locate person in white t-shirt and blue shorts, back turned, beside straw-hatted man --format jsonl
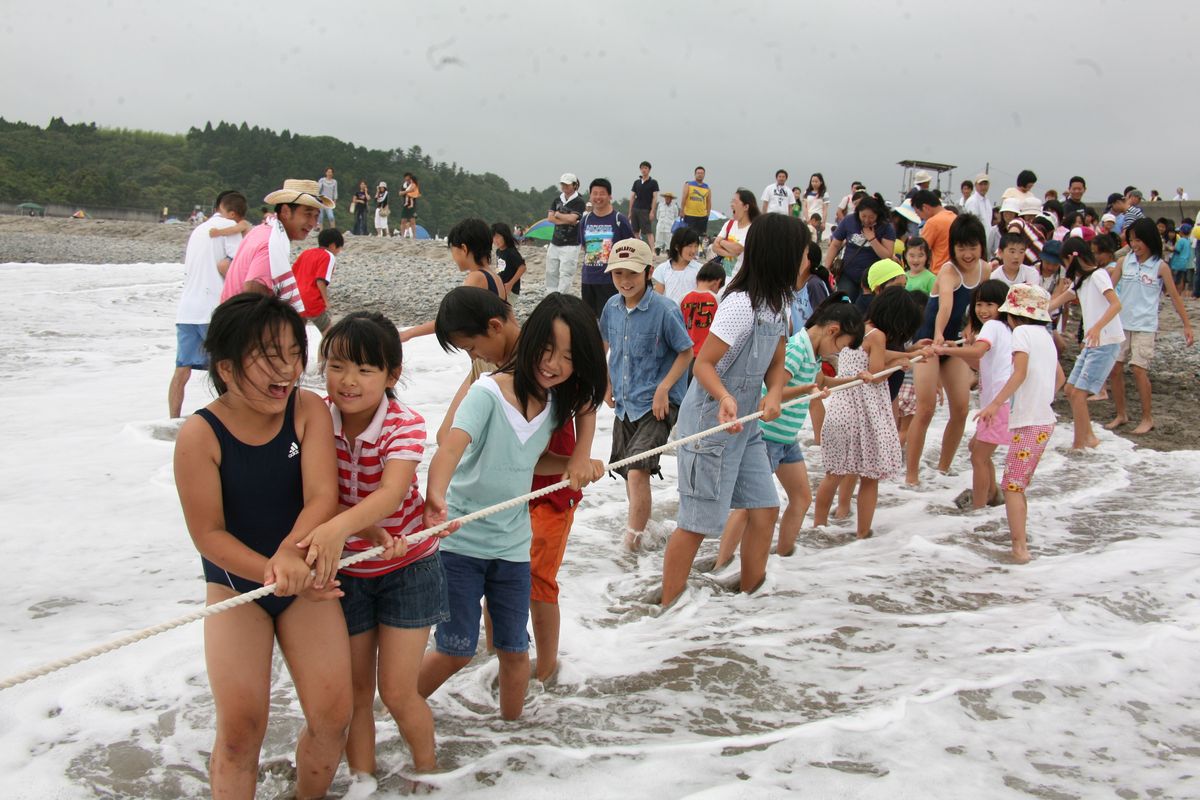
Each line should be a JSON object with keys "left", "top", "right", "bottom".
{"left": 167, "top": 192, "right": 246, "bottom": 419}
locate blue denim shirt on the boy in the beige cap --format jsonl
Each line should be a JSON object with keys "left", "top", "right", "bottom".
{"left": 600, "top": 288, "right": 691, "bottom": 421}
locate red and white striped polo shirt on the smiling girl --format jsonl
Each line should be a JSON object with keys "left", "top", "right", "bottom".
{"left": 325, "top": 397, "right": 439, "bottom": 578}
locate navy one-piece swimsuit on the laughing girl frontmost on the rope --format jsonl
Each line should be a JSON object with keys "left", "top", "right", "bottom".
{"left": 196, "top": 392, "right": 304, "bottom": 616}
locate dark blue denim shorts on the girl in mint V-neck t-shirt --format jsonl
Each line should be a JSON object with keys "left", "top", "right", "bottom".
{"left": 433, "top": 551, "right": 532, "bottom": 658}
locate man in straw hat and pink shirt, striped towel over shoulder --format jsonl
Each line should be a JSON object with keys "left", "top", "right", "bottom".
{"left": 221, "top": 178, "right": 334, "bottom": 313}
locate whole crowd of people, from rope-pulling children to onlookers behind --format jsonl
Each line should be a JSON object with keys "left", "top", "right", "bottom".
{"left": 169, "top": 162, "right": 1195, "bottom": 796}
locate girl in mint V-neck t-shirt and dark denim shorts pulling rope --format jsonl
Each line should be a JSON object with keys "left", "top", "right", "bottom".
{"left": 419, "top": 293, "right": 606, "bottom": 720}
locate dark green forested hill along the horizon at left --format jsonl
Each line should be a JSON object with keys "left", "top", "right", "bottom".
{"left": 0, "top": 116, "right": 558, "bottom": 235}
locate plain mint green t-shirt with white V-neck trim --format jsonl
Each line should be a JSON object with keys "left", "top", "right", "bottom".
{"left": 442, "top": 375, "right": 554, "bottom": 561}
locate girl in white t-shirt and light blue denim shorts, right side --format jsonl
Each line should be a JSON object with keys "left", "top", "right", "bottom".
{"left": 1050, "top": 236, "right": 1124, "bottom": 450}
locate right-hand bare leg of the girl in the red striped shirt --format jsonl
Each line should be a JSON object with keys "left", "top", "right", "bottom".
{"left": 379, "top": 625, "right": 438, "bottom": 772}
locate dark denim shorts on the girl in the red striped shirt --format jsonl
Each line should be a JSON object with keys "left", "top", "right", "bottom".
{"left": 337, "top": 552, "right": 450, "bottom": 636}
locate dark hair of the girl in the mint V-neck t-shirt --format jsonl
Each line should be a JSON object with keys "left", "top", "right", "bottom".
{"left": 499, "top": 291, "right": 608, "bottom": 428}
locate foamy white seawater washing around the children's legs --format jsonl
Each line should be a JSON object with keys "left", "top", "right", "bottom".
{"left": 0, "top": 265, "right": 1200, "bottom": 799}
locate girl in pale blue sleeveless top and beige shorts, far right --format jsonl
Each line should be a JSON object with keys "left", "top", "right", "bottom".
{"left": 1104, "top": 218, "right": 1195, "bottom": 435}
